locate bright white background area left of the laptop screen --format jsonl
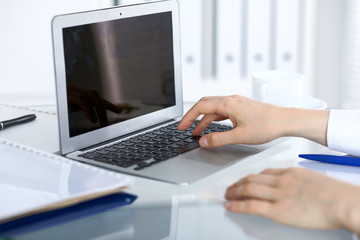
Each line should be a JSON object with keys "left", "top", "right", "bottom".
{"left": 0, "top": 0, "right": 112, "bottom": 106}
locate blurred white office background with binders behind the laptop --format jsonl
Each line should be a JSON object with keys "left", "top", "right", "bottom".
{"left": 0, "top": 0, "right": 360, "bottom": 109}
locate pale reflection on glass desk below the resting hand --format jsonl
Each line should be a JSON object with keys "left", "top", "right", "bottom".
{"left": 176, "top": 198, "right": 353, "bottom": 240}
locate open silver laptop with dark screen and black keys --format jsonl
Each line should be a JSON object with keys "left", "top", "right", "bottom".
{"left": 52, "top": 0, "right": 259, "bottom": 184}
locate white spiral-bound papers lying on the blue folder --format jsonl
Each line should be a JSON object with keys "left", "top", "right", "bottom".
{"left": 0, "top": 138, "right": 131, "bottom": 224}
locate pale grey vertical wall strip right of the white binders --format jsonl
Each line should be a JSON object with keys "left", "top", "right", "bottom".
{"left": 314, "top": 0, "right": 347, "bottom": 108}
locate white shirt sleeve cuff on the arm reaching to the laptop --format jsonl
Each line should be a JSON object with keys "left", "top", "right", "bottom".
{"left": 327, "top": 110, "right": 360, "bottom": 156}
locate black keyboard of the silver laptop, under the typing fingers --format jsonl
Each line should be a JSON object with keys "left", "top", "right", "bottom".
{"left": 78, "top": 121, "right": 232, "bottom": 171}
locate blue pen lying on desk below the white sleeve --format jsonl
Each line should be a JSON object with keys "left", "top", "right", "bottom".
{"left": 299, "top": 154, "right": 360, "bottom": 167}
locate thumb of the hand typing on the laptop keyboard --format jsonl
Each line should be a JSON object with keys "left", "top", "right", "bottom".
{"left": 199, "top": 129, "right": 238, "bottom": 148}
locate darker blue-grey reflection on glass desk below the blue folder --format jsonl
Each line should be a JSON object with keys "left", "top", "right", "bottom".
{"left": 13, "top": 200, "right": 177, "bottom": 240}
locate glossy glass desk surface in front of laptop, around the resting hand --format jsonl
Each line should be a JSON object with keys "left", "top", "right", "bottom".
{"left": 0, "top": 138, "right": 360, "bottom": 240}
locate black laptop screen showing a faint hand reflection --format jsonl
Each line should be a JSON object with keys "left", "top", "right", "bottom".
{"left": 63, "top": 12, "right": 175, "bottom": 137}
